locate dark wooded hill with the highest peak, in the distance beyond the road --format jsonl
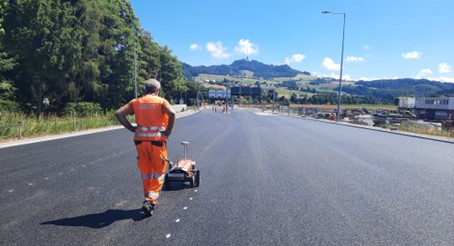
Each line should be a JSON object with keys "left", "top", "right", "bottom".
{"left": 181, "top": 59, "right": 311, "bottom": 79}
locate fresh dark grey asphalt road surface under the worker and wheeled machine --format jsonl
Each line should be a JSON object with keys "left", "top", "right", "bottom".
{"left": 0, "top": 109, "right": 454, "bottom": 245}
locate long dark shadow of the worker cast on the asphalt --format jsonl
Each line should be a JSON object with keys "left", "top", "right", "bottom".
{"left": 41, "top": 209, "right": 146, "bottom": 229}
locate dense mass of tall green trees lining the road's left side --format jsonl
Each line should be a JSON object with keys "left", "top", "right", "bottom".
{"left": 0, "top": 0, "right": 188, "bottom": 114}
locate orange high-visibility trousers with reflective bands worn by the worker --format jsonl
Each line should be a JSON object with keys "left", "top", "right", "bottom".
{"left": 136, "top": 141, "right": 167, "bottom": 204}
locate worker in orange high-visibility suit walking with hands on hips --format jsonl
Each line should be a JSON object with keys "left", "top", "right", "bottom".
{"left": 115, "top": 79, "right": 176, "bottom": 216}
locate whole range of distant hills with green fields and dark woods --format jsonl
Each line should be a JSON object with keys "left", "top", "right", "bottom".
{"left": 182, "top": 59, "right": 454, "bottom": 104}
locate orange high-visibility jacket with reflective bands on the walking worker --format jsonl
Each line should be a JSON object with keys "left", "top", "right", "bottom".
{"left": 128, "top": 95, "right": 171, "bottom": 141}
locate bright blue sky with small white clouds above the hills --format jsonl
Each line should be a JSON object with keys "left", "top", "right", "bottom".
{"left": 130, "top": 0, "right": 454, "bottom": 83}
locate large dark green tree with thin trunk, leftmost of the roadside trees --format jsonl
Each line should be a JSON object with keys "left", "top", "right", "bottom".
{"left": 3, "top": 0, "right": 81, "bottom": 114}
